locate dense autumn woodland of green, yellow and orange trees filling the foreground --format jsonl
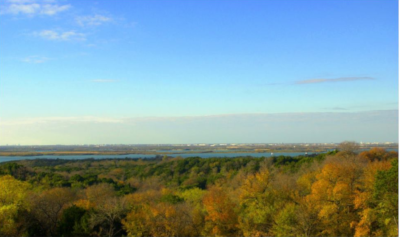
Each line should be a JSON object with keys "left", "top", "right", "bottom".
{"left": 0, "top": 142, "right": 398, "bottom": 236}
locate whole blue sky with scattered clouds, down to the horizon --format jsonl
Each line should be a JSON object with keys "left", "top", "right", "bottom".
{"left": 0, "top": 0, "right": 399, "bottom": 145}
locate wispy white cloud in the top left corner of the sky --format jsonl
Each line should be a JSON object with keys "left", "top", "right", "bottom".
{"left": 0, "top": 0, "right": 71, "bottom": 16}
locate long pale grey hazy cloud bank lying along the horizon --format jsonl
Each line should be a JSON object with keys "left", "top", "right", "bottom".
{"left": 0, "top": 110, "right": 398, "bottom": 145}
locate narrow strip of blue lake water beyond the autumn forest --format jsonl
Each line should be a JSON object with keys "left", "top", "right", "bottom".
{"left": 0, "top": 152, "right": 312, "bottom": 163}
